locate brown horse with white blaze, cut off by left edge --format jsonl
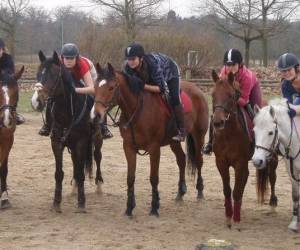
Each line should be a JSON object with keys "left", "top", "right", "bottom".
{"left": 0, "top": 66, "right": 24, "bottom": 209}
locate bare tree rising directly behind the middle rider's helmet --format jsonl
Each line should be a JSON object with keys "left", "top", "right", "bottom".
{"left": 90, "top": 0, "right": 164, "bottom": 41}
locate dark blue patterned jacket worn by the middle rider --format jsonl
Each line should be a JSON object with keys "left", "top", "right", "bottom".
{"left": 125, "top": 53, "right": 179, "bottom": 93}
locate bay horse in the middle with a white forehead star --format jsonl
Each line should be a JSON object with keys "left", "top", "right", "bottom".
{"left": 91, "top": 63, "right": 208, "bottom": 217}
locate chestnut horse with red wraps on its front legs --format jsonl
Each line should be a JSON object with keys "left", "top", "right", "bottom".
{"left": 212, "top": 70, "right": 278, "bottom": 230}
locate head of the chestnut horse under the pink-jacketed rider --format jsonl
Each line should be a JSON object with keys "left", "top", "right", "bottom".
{"left": 212, "top": 70, "right": 240, "bottom": 129}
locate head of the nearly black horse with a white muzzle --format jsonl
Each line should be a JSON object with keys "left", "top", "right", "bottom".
{"left": 31, "top": 51, "right": 72, "bottom": 112}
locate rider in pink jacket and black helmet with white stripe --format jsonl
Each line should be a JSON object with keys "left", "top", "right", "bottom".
{"left": 203, "top": 49, "right": 262, "bottom": 154}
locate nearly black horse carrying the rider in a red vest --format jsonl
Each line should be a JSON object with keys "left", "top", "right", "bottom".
{"left": 31, "top": 51, "right": 103, "bottom": 213}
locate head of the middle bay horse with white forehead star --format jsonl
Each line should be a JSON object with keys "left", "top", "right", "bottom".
{"left": 90, "top": 63, "right": 119, "bottom": 122}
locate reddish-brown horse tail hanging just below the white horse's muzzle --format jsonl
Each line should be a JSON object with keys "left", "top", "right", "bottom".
{"left": 256, "top": 168, "right": 269, "bottom": 204}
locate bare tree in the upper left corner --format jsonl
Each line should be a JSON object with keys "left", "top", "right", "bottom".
{"left": 0, "top": 0, "right": 30, "bottom": 56}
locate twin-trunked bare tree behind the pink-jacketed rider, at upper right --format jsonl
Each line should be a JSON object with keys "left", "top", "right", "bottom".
{"left": 207, "top": 0, "right": 300, "bottom": 66}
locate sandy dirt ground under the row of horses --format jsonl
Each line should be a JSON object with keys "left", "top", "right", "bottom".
{"left": 0, "top": 113, "right": 300, "bottom": 249}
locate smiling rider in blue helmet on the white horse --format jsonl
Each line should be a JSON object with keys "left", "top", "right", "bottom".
{"left": 277, "top": 53, "right": 300, "bottom": 118}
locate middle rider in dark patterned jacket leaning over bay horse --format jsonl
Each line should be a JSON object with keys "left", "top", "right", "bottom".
{"left": 124, "top": 42, "right": 186, "bottom": 141}
